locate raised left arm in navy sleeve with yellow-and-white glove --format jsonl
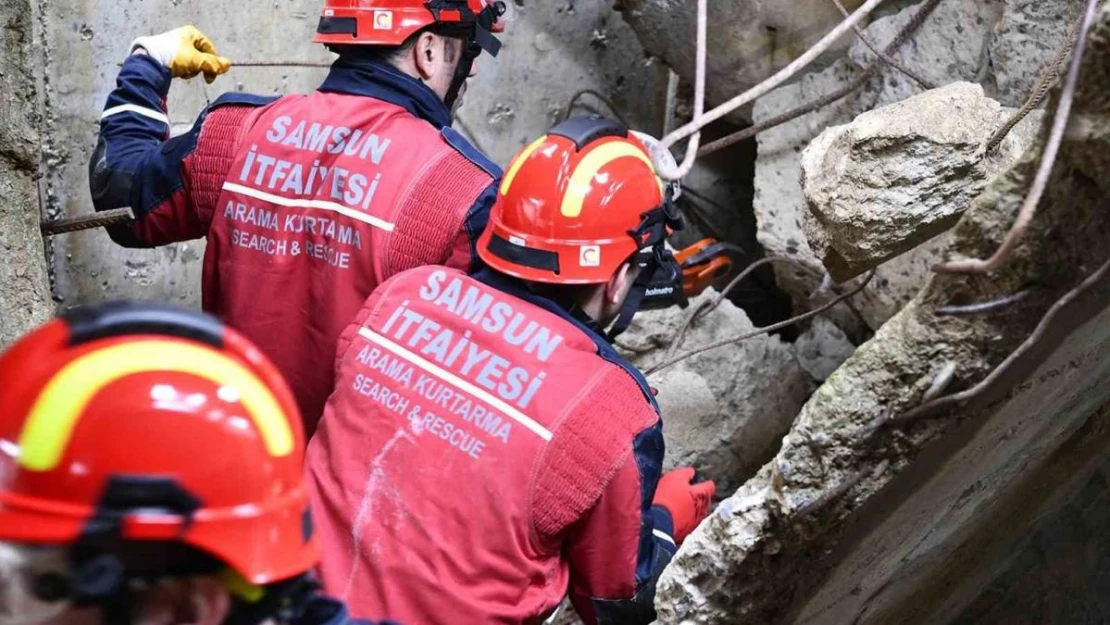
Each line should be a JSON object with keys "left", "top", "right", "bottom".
{"left": 89, "top": 27, "right": 243, "bottom": 248}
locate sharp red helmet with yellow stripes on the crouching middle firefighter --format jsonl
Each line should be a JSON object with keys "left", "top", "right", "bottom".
{"left": 478, "top": 115, "right": 677, "bottom": 284}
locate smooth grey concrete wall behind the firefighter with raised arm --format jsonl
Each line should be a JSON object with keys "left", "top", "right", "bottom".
{"left": 37, "top": 0, "right": 666, "bottom": 306}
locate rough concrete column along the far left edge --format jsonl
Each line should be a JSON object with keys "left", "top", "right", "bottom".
{"left": 0, "top": 0, "right": 53, "bottom": 349}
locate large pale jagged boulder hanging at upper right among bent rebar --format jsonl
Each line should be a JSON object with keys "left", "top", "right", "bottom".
{"left": 801, "top": 82, "right": 1040, "bottom": 282}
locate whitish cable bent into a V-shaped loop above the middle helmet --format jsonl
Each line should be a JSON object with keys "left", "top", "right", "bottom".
{"left": 655, "top": 0, "right": 884, "bottom": 181}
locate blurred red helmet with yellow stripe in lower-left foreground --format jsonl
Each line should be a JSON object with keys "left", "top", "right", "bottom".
{"left": 0, "top": 304, "right": 319, "bottom": 585}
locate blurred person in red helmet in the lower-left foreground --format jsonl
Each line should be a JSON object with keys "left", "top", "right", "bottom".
{"left": 0, "top": 304, "right": 399, "bottom": 625}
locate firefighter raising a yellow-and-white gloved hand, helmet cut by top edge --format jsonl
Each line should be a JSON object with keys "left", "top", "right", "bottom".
{"left": 90, "top": 0, "right": 504, "bottom": 436}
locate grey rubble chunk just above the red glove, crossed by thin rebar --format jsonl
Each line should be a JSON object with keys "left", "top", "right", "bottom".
{"left": 618, "top": 289, "right": 814, "bottom": 493}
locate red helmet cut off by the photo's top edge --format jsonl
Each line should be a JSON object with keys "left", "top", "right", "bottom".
{"left": 313, "top": 0, "right": 505, "bottom": 57}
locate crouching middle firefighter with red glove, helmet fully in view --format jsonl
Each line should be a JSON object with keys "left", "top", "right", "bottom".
{"left": 307, "top": 118, "right": 714, "bottom": 624}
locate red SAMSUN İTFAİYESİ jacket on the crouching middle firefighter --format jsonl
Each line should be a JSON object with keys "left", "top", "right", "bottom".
{"left": 306, "top": 266, "right": 675, "bottom": 624}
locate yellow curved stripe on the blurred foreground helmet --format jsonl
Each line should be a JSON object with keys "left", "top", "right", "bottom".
{"left": 19, "top": 340, "right": 293, "bottom": 471}
